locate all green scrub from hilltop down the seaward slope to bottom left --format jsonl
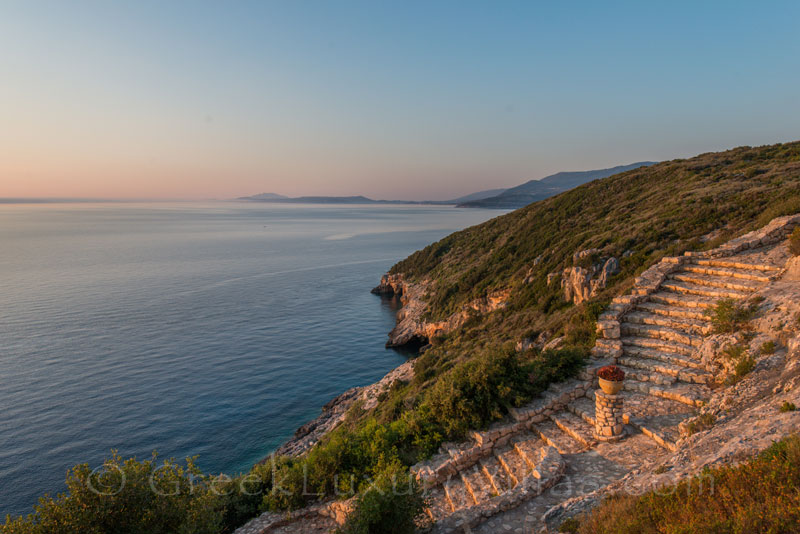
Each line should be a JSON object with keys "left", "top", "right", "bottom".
{"left": 6, "top": 142, "right": 800, "bottom": 534}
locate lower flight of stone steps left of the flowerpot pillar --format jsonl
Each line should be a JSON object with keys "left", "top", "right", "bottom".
{"left": 412, "top": 378, "right": 595, "bottom": 532}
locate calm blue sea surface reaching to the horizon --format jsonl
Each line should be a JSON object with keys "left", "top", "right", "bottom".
{"left": 0, "top": 202, "right": 500, "bottom": 517}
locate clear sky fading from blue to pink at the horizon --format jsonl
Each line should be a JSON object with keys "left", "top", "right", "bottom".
{"left": 0, "top": 0, "right": 800, "bottom": 199}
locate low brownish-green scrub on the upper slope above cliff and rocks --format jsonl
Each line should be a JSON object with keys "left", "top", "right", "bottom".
{"left": 392, "top": 142, "right": 800, "bottom": 330}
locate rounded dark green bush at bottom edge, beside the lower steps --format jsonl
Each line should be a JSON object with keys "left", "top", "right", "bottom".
{"left": 337, "top": 465, "right": 425, "bottom": 534}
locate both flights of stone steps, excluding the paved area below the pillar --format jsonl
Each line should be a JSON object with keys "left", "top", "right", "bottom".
{"left": 419, "top": 244, "right": 780, "bottom": 532}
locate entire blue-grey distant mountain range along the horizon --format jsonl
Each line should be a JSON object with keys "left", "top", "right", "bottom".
{"left": 237, "top": 161, "right": 656, "bottom": 209}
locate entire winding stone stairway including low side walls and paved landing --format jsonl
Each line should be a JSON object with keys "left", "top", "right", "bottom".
{"left": 237, "top": 215, "right": 800, "bottom": 534}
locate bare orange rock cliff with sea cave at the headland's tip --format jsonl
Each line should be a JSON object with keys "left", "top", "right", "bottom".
{"left": 372, "top": 274, "right": 511, "bottom": 349}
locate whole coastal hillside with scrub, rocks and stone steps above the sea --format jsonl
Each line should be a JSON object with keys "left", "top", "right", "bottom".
{"left": 9, "top": 142, "right": 800, "bottom": 534}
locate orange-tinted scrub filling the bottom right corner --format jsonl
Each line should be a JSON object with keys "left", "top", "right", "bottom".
{"left": 567, "top": 435, "right": 800, "bottom": 534}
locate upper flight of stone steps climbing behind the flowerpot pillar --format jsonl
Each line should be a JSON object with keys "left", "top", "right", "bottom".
{"left": 599, "top": 249, "right": 780, "bottom": 450}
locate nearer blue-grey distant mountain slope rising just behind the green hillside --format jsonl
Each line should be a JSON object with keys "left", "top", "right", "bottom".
{"left": 458, "top": 161, "right": 655, "bottom": 209}
